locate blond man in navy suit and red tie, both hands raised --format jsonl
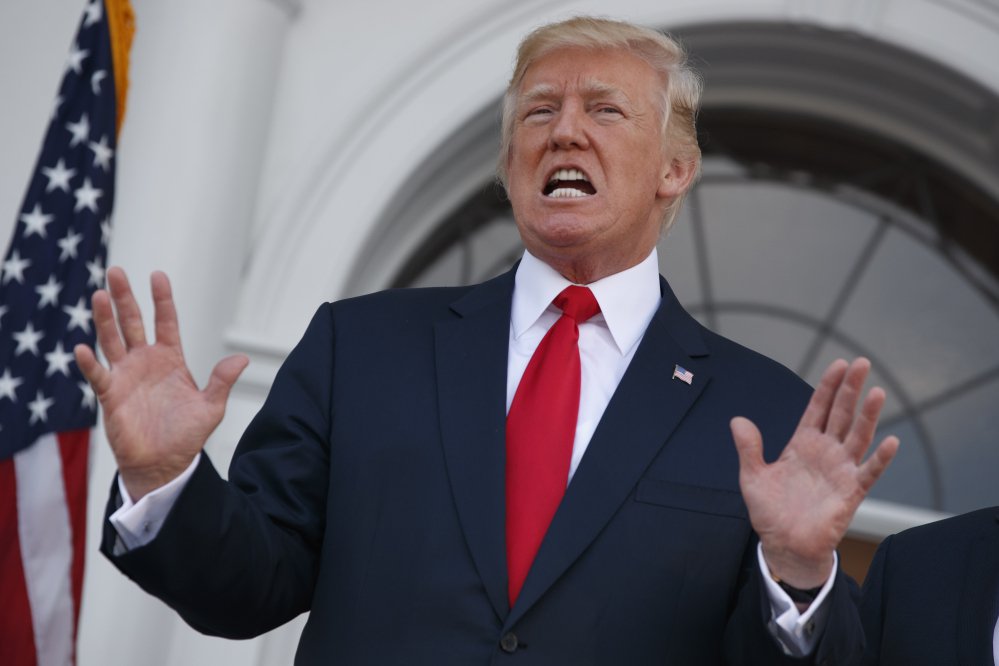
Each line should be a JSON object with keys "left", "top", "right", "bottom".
{"left": 77, "top": 19, "right": 898, "bottom": 666}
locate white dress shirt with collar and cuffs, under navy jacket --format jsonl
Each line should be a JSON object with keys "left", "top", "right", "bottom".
{"left": 110, "top": 249, "right": 837, "bottom": 655}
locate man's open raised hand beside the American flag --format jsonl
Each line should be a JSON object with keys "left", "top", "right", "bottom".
{"left": 74, "top": 268, "right": 249, "bottom": 501}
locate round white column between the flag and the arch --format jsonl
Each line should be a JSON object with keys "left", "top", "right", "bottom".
{"left": 75, "top": 0, "right": 293, "bottom": 666}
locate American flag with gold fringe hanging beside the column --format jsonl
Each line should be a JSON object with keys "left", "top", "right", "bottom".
{"left": 0, "top": 0, "right": 132, "bottom": 666}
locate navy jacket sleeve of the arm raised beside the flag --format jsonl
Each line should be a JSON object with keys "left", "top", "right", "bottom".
{"left": 101, "top": 305, "right": 334, "bottom": 638}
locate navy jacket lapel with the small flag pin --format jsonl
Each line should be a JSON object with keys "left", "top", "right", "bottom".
{"left": 506, "top": 281, "right": 710, "bottom": 627}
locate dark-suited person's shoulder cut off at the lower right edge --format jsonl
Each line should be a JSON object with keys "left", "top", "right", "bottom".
{"left": 860, "top": 507, "right": 999, "bottom": 666}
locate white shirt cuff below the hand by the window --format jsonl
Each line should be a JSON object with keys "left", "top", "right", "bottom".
{"left": 756, "top": 544, "right": 839, "bottom": 657}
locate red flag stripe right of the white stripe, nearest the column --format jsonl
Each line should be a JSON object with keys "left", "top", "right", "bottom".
{"left": 59, "top": 430, "right": 90, "bottom": 646}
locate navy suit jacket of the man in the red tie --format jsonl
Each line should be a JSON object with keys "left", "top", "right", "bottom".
{"left": 103, "top": 272, "right": 862, "bottom": 666}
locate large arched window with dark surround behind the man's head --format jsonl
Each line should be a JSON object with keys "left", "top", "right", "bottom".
{"left": 386, "top": 25, "right": 999, "bottom": 513}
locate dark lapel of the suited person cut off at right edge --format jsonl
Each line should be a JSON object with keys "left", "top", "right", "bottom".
{"left": 957, "top": 510, "right": 999, "bottom": 666}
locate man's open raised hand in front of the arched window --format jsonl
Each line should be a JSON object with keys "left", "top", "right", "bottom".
{"left": 731, "top": 358, "right": 898, "bottom": 589}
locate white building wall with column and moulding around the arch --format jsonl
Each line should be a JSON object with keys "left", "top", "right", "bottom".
{"left": 0, "top": 0, "right": 999, "bottom": 666}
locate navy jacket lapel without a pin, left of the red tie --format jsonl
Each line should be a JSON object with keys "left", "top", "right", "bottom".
{"left": 435, "top": 271, "right": 514, "bottom": 620}
